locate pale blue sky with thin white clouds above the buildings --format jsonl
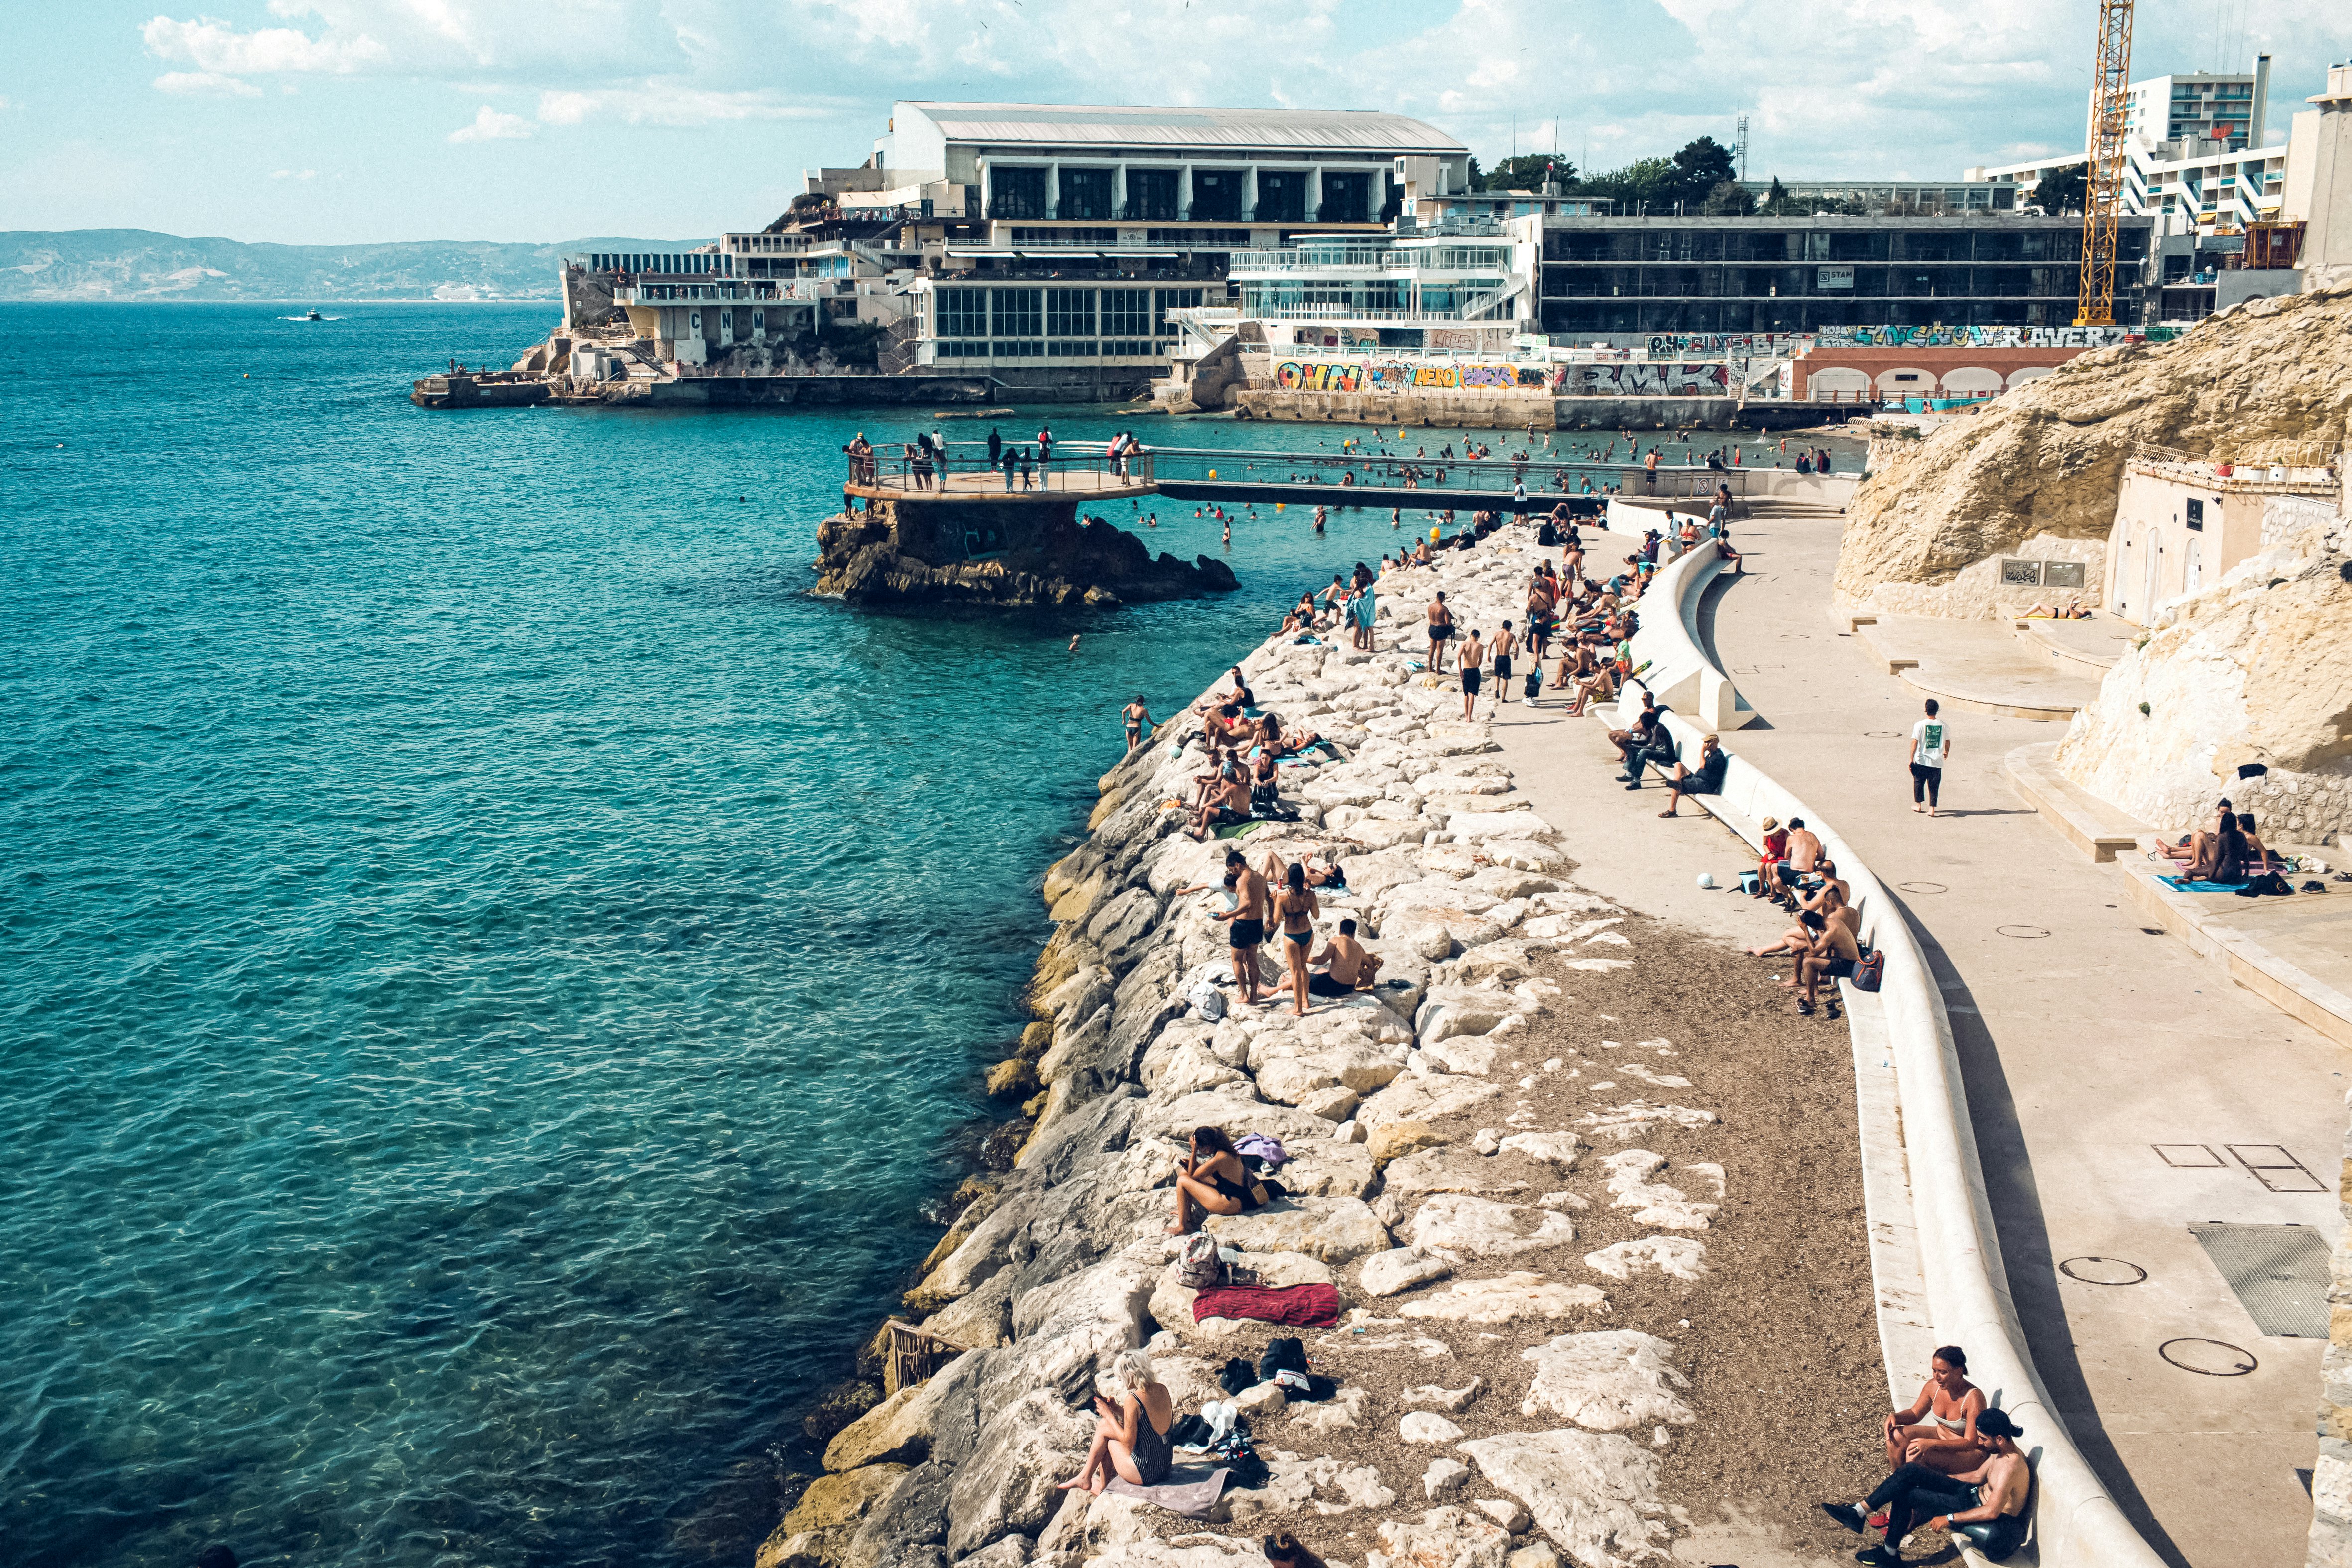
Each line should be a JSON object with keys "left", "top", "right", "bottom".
{"left": 0, "top": 0, "right": 2352, "bottom": 244}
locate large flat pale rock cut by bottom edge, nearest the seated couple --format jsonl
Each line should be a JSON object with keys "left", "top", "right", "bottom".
{"left": 1456, "top": 1427, "right": 1672, "bottom": 1568}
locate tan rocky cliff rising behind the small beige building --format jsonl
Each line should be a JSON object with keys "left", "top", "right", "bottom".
{"left": 1837, "top": 287, "right": 2352, "bottom": 618}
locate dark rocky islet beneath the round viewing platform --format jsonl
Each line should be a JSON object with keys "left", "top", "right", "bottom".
{"left": 816, "top": 501, "right": 1240, "bottom": 609}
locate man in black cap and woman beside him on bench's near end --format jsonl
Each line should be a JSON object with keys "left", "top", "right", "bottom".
{"left": 1820, "top": 1344, "right": 2034, "bottom": 1568}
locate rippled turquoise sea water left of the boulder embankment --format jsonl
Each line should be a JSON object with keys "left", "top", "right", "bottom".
{"left": 0, "top": 306, "right": 1580, "bottom": 1568}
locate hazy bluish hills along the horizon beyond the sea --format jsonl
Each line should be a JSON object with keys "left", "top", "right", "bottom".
{"left": 0, "top": 228, "right": 710, "bottom": 303}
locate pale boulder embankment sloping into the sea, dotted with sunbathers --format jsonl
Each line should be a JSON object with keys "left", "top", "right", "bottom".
{"left": 757, "top": 531, "right": 1884, "bottom": 1568}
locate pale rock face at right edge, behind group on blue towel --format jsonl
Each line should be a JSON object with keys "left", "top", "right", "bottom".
{"left": 2058, "top": 503, "right": 2352, "bottom": 844}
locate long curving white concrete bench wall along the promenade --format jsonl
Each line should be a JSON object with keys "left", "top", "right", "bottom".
{"left": 1618, "top": 524, "right": 2164, "bottom": 1568}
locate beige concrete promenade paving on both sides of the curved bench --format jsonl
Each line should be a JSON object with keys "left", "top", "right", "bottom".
{"left": 1496, "top": 517, "right": 2352, "bottom": 1568}
